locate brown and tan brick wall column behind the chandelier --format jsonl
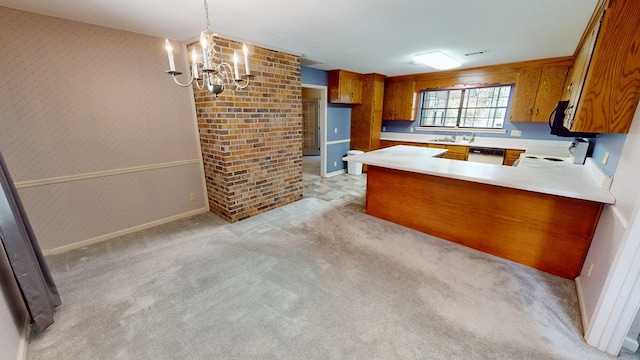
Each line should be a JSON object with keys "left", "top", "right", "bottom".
{"left": 194, "top": 38, "right": 302, "bottom": 222}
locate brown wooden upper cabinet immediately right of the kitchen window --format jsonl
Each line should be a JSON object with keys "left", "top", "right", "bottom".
{"left": 509, "top": 66, "right": 569, "bottom": 122}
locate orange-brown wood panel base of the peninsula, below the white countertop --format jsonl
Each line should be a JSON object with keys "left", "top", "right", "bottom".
{"left": 366, "top": 165, "right": 603, "bottom": 280}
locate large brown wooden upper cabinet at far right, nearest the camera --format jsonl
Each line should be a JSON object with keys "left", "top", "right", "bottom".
{"left": 563, "top": 0, "right": 640, "bottom": 133}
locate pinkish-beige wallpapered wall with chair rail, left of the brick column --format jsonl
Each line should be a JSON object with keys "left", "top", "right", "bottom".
{"left": 0, "top": 7, "right": 207, "bottom": 249}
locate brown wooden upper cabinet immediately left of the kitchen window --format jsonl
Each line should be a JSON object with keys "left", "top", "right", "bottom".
{"left": 382, "top": 81, "right": 416, "bottom": 120}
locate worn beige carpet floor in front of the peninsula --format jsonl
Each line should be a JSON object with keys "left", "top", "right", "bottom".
{"left": 27, "top": 162, "right": 614, "bottom": 360}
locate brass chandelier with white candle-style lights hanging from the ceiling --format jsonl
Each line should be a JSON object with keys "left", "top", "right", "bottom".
{"left": 164, "top": 0, "right": 252, "bottom": 97}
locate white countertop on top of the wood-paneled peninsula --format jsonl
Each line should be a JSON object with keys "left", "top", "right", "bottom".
{"left": 343, "top": 145, "right": 615, "bottom": 204}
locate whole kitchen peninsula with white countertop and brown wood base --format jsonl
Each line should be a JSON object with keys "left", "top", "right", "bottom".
{"left": 344, "top": 145, "right": 615, "bottom": 279}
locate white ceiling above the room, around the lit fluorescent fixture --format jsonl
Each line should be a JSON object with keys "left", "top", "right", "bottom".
{"left": 0, "top": 0, "right": 597, "bottom": 76}
